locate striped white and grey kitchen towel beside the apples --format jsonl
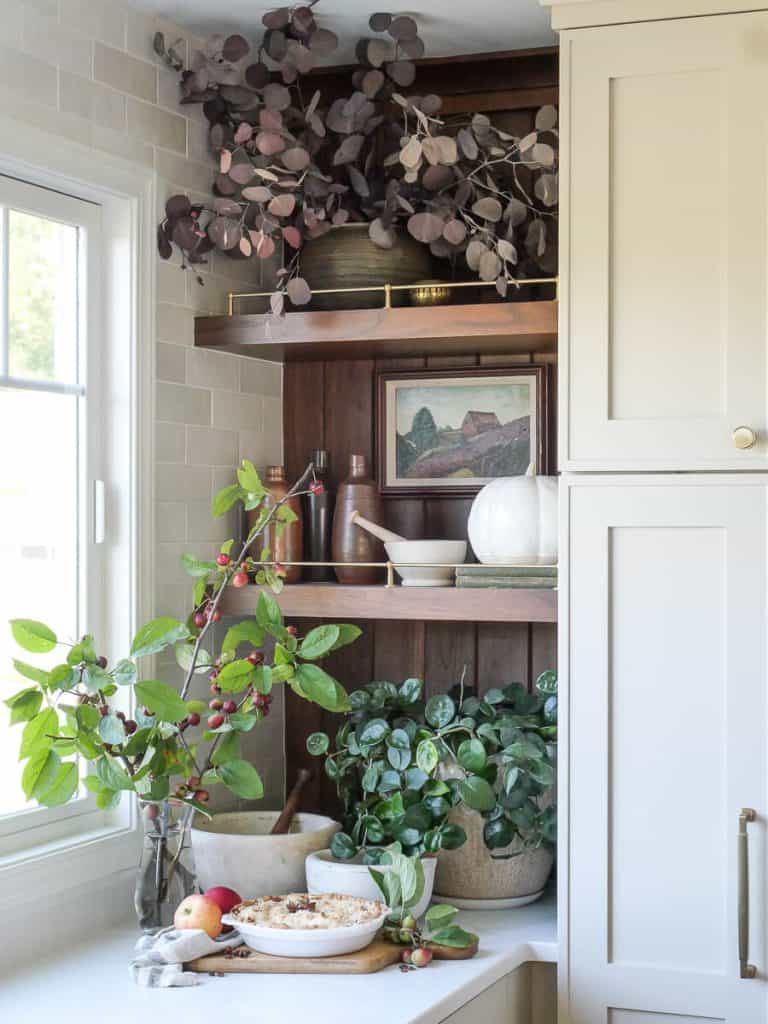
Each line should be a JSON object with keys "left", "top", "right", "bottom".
{"left": 130, "top": 928, "right": 243, "bottom": 988}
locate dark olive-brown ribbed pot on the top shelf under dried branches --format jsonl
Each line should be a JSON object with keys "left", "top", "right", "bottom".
{"left": 301, "top": 224, "right": 432, "bottom": 309}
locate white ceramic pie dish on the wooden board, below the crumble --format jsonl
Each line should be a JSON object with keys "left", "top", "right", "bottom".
{"left": 221, "top": 908, "right": 389, "bottom": 956}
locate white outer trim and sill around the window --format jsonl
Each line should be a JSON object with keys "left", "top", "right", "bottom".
{"left": 0, "top": 116, "right": 156, "bottom": 908}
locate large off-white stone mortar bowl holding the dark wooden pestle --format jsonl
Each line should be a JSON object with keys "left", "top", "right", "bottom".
{"left": 190, "top": 811, "right": 341, "bottom": 899}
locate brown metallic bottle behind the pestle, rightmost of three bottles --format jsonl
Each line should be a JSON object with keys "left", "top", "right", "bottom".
{"left": 332, "top": 455, "right": 386, "bottom": 585}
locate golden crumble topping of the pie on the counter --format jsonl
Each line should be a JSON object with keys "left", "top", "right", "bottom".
{"left": 231, "top": 893, "right": 386, "bottom": 930}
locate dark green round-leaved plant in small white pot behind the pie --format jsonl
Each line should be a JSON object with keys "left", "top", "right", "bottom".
{"left": 306, "top": 679, "right": 466, "bottom": 916}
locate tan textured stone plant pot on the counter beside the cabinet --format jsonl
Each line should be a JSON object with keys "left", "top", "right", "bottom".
{"left": 435, "top": 807, "right": 554, "bottom": 902}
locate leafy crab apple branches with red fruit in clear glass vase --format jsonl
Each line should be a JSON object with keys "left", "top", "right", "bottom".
{"left": 5, "top": 461, "right": 359, "bottom": 929}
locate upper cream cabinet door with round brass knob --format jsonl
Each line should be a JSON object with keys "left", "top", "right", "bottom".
{"left": 556, "top": 11, "right": 768, "bottom": 471}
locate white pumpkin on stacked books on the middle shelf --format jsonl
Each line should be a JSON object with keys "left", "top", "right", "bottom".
{"left": 468, "top": 465, "right": 557, "bottom": 565}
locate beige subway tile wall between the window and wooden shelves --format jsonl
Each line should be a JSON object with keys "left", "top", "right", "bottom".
{"left": 0, "top": 0, "right": 284, "bottom": 807}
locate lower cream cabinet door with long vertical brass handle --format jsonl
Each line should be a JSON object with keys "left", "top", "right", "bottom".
{"left": 561, "top": 476, "right": 768, "bottom": 1024}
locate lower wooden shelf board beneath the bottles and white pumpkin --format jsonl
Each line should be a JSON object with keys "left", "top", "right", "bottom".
{"left": 220, "top": 583, "right": 557, "bottom": 623}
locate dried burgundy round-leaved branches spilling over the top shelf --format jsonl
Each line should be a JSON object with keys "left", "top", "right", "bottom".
{"left": 155, "top": 3, "right": 557, "bottom": 313}
